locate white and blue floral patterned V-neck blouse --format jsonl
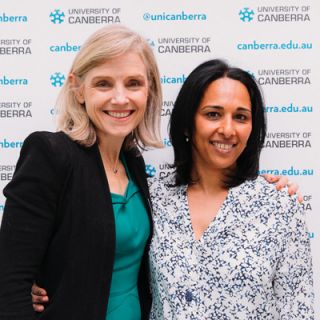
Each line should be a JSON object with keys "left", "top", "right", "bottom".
{"left": 149, "top": 175, "right": 314, "bottom": 320}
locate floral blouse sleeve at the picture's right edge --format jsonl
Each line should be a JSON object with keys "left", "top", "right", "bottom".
{"left": 274, "top": 199, "right": 314, "bottom": 320}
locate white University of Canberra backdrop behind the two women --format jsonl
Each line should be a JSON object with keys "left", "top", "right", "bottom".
{"left": 0, "top": 0, "right": 320, "bottom": 319}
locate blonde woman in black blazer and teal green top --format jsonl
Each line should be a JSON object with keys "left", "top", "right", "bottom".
{"left": 0, "top": 25, "right": 162, "bottom": 320}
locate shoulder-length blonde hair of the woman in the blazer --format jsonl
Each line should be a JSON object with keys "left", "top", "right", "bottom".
{"left": 56, "top": 25, "right": 162, "bottom": 149}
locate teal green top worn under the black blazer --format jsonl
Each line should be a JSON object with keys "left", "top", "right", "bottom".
{"left": 106, "top": 158, "right": 150, "bottom": 320}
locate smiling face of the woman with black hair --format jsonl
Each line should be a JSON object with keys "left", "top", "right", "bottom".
{"left": 192, "top": 77, "right": 252, "bottom": 178}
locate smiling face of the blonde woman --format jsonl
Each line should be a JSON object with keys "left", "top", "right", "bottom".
{"left": 76, "top": 52, "right": 149, "bottom": 143}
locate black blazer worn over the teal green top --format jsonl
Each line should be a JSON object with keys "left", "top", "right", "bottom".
{"left": 0, "top": 132, "right": 151, "bottom": 320}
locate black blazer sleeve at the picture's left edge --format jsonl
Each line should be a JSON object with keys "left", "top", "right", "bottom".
{"left": 0, "top": 133, "right": 69, "bottom": 320}
